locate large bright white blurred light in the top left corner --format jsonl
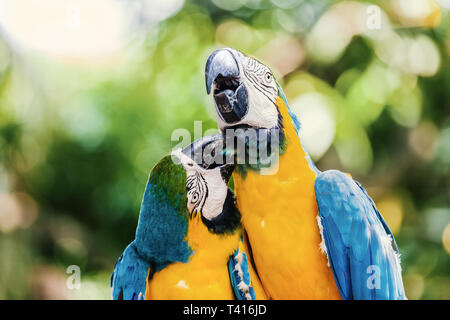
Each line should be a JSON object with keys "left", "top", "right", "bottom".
{"left": 0, "top": 0, "right": 125, "bottom": 62}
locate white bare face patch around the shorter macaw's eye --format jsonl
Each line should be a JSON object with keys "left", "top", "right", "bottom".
{"left": 172, "top": 149, "right": 228, "bottom": 220}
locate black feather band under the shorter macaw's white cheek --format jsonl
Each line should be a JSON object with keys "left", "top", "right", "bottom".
{"left": 202, "top": 189, "right": 241, "bottom": 234}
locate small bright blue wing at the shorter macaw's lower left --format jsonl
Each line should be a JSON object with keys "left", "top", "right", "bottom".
{"left": 111, "top": 241, "right": 150, "bottom": 300}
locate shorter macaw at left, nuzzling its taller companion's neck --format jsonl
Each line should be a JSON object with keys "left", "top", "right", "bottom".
{"left": 111, "top": 135, "right": 266, "bottom": 300}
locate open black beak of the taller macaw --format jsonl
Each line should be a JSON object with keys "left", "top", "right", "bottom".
{"left": 205, "top": 49, "right": 248, "bottom": 124}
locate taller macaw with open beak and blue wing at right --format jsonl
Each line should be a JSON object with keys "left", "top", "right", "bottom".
{"left": 205, "top": 48, "right": 406, "bottom": 300}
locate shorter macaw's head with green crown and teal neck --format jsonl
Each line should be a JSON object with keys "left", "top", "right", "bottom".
{"left": 136, "top": 135, "right": 240, "bottom": 270}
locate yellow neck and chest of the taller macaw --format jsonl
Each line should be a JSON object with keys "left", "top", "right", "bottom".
{"left": 233, "top": 101, "right": 340, "bottom": 299}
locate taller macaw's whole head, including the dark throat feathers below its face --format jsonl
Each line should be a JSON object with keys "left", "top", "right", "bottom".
{"left": 205, "top": 48, "right": 300, "bottom": 172}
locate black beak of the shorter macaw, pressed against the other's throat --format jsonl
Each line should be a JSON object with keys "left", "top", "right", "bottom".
{"left": 182, "top": 134, "right": 234, "bottom": 182}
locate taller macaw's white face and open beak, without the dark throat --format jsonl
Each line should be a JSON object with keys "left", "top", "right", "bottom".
{"left": 205, "top": 48, "right": 284, "bottom": 131}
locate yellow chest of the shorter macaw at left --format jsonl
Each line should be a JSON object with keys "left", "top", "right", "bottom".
{"left": 146, "top": 214, "right": 241, "bottom": 300}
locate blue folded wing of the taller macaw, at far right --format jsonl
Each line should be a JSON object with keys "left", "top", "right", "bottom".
{"left": 315, "top": 170, "right": 406, "bottom": 300}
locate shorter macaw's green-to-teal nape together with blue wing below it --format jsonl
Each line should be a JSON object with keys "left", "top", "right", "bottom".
{"left": 111, "top": 156, "right": 192, "bottom": 300}
